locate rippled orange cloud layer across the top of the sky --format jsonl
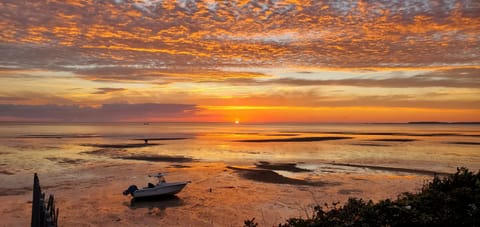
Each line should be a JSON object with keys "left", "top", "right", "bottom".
{"left": 0, "top": 1, "right": 480, "bottom": 67}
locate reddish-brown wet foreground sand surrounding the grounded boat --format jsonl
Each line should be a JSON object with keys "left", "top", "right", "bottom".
{"left": 0, "top": 161, "right": 425, "bottom": 226}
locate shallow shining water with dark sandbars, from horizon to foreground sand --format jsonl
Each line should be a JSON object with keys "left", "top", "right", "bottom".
{"left": 0, "top": 123, "right": 480, "bottom": 177}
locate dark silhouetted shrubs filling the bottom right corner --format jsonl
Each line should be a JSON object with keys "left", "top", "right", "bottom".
{"left": 245, "top": 168, "right": 480, "bottom": 227}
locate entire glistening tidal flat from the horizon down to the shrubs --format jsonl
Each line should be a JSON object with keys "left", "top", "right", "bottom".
{"left": 0, "top": 124, "right": 480, "bottom": 226}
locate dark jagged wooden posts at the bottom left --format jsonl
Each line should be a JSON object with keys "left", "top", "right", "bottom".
{"left": 31, "top": 173, "right": 58, "bottom": 227}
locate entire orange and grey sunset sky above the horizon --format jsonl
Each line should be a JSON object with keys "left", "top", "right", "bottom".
{"left": 0, "top": 0, "right": 480, "bottom": 123}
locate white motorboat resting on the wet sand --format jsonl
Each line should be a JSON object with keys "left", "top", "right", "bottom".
{"left": 123, "top": 173, "right": 190, "bottom": 198}
